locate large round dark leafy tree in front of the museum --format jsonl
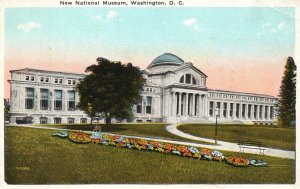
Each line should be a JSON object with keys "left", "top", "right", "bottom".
{"left": 76, "top": 58, "right": 145, "bottom": 125}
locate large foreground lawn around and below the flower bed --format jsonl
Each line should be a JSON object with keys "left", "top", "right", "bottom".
{"left": 5, "top": 127, "right": 295, "bottom": 184}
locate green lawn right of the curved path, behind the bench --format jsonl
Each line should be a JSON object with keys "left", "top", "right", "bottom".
{"left": 178, "top": 124, "right": 295, "bottom": 150}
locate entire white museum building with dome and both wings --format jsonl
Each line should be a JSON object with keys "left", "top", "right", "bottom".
{"left": 9, "top": 53, "right": 277, "bottom": 123}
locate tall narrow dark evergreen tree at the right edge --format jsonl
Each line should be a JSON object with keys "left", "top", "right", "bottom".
{"left": 278, "top": 57, "right": 297, "bottom": 127}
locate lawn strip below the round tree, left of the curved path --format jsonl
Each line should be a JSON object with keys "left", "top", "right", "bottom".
{"left": 37, "top": 123, "right": 212, "bottom": 144}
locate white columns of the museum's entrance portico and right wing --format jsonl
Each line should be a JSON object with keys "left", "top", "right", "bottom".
{"left": 169, "top": 92, "right": 275, "bottom": 121}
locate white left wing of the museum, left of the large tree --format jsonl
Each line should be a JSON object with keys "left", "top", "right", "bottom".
{"left": 9, "top": 68, "right": 88, "bottom": 124}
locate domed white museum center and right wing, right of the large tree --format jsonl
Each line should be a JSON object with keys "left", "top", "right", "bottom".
{"left": 133, "top": 53, "right": 277, "bottom": 123}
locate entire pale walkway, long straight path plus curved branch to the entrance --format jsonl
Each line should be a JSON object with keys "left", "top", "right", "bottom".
{"left": 5, "top": 125, "right": 295, "bottom": 159}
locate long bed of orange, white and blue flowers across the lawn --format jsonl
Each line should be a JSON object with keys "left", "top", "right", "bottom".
{"left": 61, "top": 131, "right": 266, "bottom": 167}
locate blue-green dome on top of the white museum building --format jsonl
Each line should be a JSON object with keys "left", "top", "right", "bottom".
{"left": 148, "top": 53, "right": 184, "bottom": 68}
